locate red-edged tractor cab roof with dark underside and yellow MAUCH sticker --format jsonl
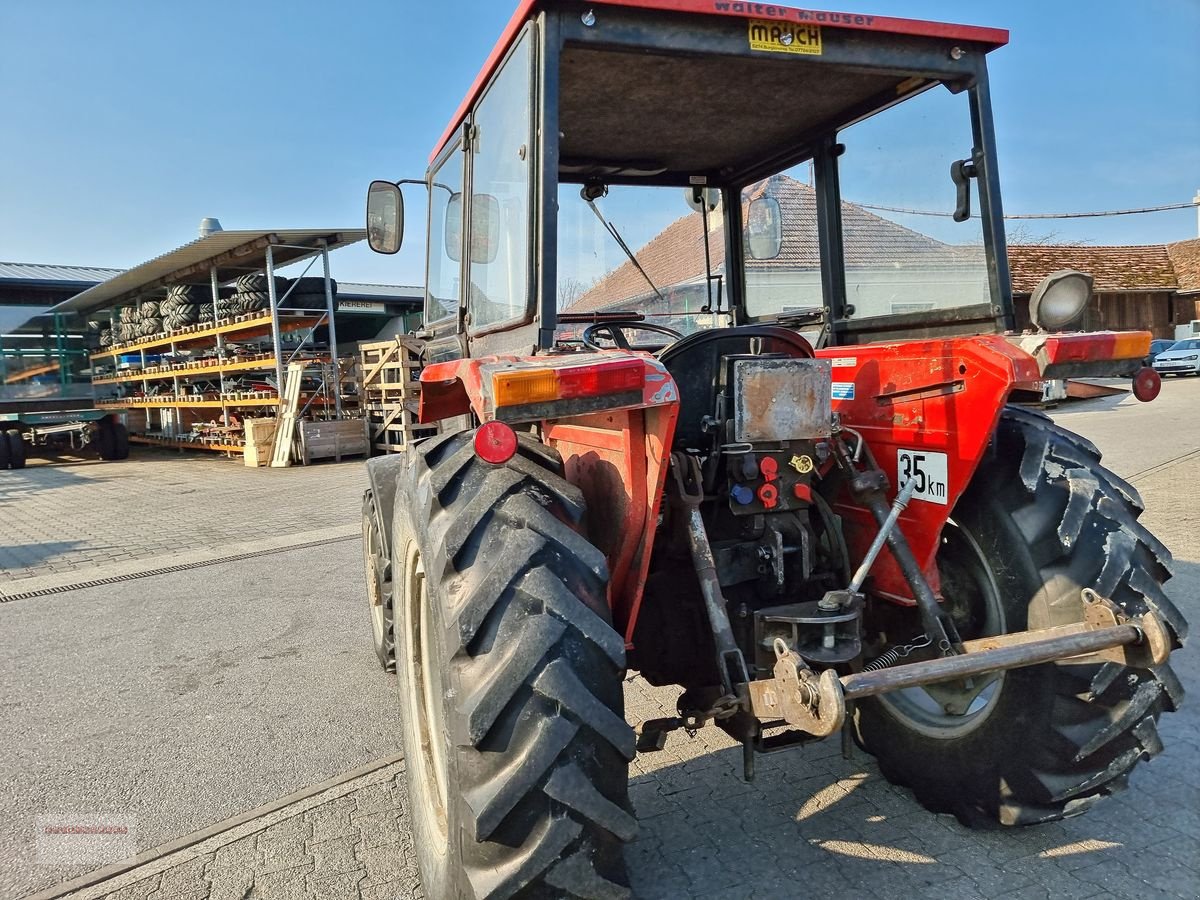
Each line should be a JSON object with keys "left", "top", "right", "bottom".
{"left": 431, "top": 0, "right": 1008, "bottom": 184}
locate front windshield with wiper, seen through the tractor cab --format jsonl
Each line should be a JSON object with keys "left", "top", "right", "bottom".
{"left": 557, "top": 184, "right": 730, "bottom": 344}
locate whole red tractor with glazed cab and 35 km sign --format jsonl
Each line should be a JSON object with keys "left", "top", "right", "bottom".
{"left": 364, "top": 0, "right": 1186, "bottom": 898}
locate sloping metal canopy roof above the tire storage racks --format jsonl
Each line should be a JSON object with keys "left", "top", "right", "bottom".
{"left": 50, "top": 228, "right": 367, "bottom": 316}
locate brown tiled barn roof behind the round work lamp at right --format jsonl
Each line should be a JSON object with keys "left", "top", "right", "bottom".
{"left": 1008, "top": 244, "right": 1178, "bottom": 294}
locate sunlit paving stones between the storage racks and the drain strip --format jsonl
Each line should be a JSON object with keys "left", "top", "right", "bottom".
{"left": 0, "top": 449, "right": 365, "bottom": 589}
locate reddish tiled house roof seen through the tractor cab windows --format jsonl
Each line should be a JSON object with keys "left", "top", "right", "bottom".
{"left": 570, "top": 175, "right": 983, "bottom": 312}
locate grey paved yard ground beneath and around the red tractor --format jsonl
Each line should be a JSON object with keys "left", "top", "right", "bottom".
{"left": 0, "top": 379, "right": 1200, "bottom": 900}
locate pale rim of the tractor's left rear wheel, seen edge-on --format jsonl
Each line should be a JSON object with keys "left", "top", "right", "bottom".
{"left": 403, "top": 545, "right": 449, "bottom": 853}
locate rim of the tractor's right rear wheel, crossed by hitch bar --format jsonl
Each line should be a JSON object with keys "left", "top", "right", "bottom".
{"left": 880, "top": 520, "right": 1007, "bottom": 740}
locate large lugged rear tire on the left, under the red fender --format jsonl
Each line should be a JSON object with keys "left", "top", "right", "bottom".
{"left": 391, "top": 431, "right": 637, "bottom": 898}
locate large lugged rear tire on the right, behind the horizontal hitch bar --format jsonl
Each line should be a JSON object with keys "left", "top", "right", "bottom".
{"left": 854, "top": 408, "right": 1187, "bottom": 826}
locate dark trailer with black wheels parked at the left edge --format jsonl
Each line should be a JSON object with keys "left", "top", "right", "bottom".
{"left": 0, "top": 409, "right": 130, "bottom": 469}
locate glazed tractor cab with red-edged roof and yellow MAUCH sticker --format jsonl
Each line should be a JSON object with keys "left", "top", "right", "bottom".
{"left": 368, "top": 0, "right": 1032, "bottom": 367}
